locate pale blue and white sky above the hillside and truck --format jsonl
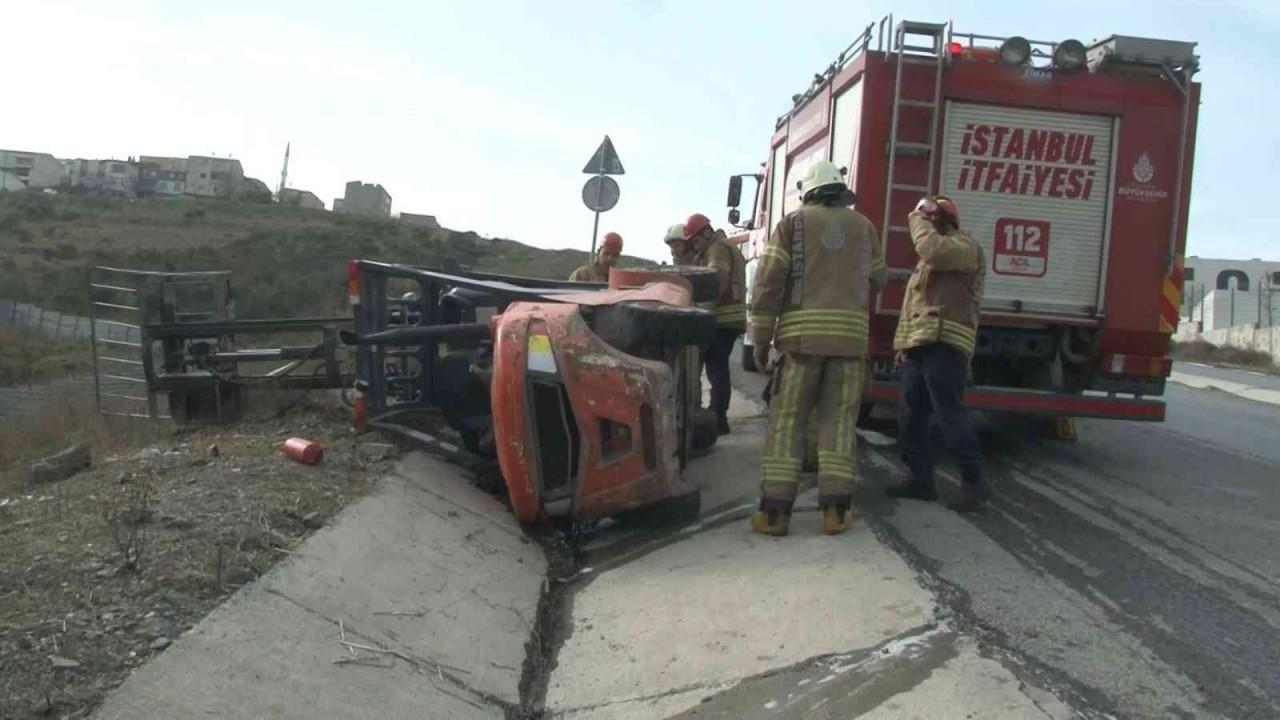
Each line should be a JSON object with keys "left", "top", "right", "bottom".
{"left": 0, "top": 0, "right": 1280, "bottom": 259}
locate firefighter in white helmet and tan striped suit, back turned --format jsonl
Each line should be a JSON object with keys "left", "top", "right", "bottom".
{"left": 751, "top": 160, "right": 886, "bottom": 536}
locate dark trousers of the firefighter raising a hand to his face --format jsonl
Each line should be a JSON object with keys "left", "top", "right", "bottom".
{"left": 897, "top": 343, "right": 984, "bottom": 487}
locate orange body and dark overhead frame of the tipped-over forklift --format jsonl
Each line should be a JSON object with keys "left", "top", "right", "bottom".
{"left": 344, "top": 260, "right": 717, "bottom": 523}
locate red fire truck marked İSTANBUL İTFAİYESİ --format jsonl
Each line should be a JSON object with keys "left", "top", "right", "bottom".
{"left": 728, "top": 18, "right": 1199, "bottom": 421}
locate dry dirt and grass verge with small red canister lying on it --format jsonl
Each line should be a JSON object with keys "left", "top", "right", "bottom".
{"left": 0, "top": 404, "right": 390, "bottom": 720}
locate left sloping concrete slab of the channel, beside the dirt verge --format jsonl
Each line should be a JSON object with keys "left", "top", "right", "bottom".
{"left": 96, "top": 454, "right": 547, "bottom": 720}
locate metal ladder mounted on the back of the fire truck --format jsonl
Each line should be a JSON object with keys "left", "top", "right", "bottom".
{"left": 881, "top": 20, "right": 950, "bottom": 252}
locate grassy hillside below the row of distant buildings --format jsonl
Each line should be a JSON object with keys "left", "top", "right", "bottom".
{"left": 0, "top": 192, "right": 640, "bottom": 318}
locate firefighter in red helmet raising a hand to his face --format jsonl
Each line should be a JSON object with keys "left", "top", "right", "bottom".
{"left": 887, "top": 196, "right": 988, "bottom": 512}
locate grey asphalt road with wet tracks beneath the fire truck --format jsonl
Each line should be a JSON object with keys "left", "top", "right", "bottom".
{"left": 740, "top": 368, "right": 1280, "bottom": 717}
